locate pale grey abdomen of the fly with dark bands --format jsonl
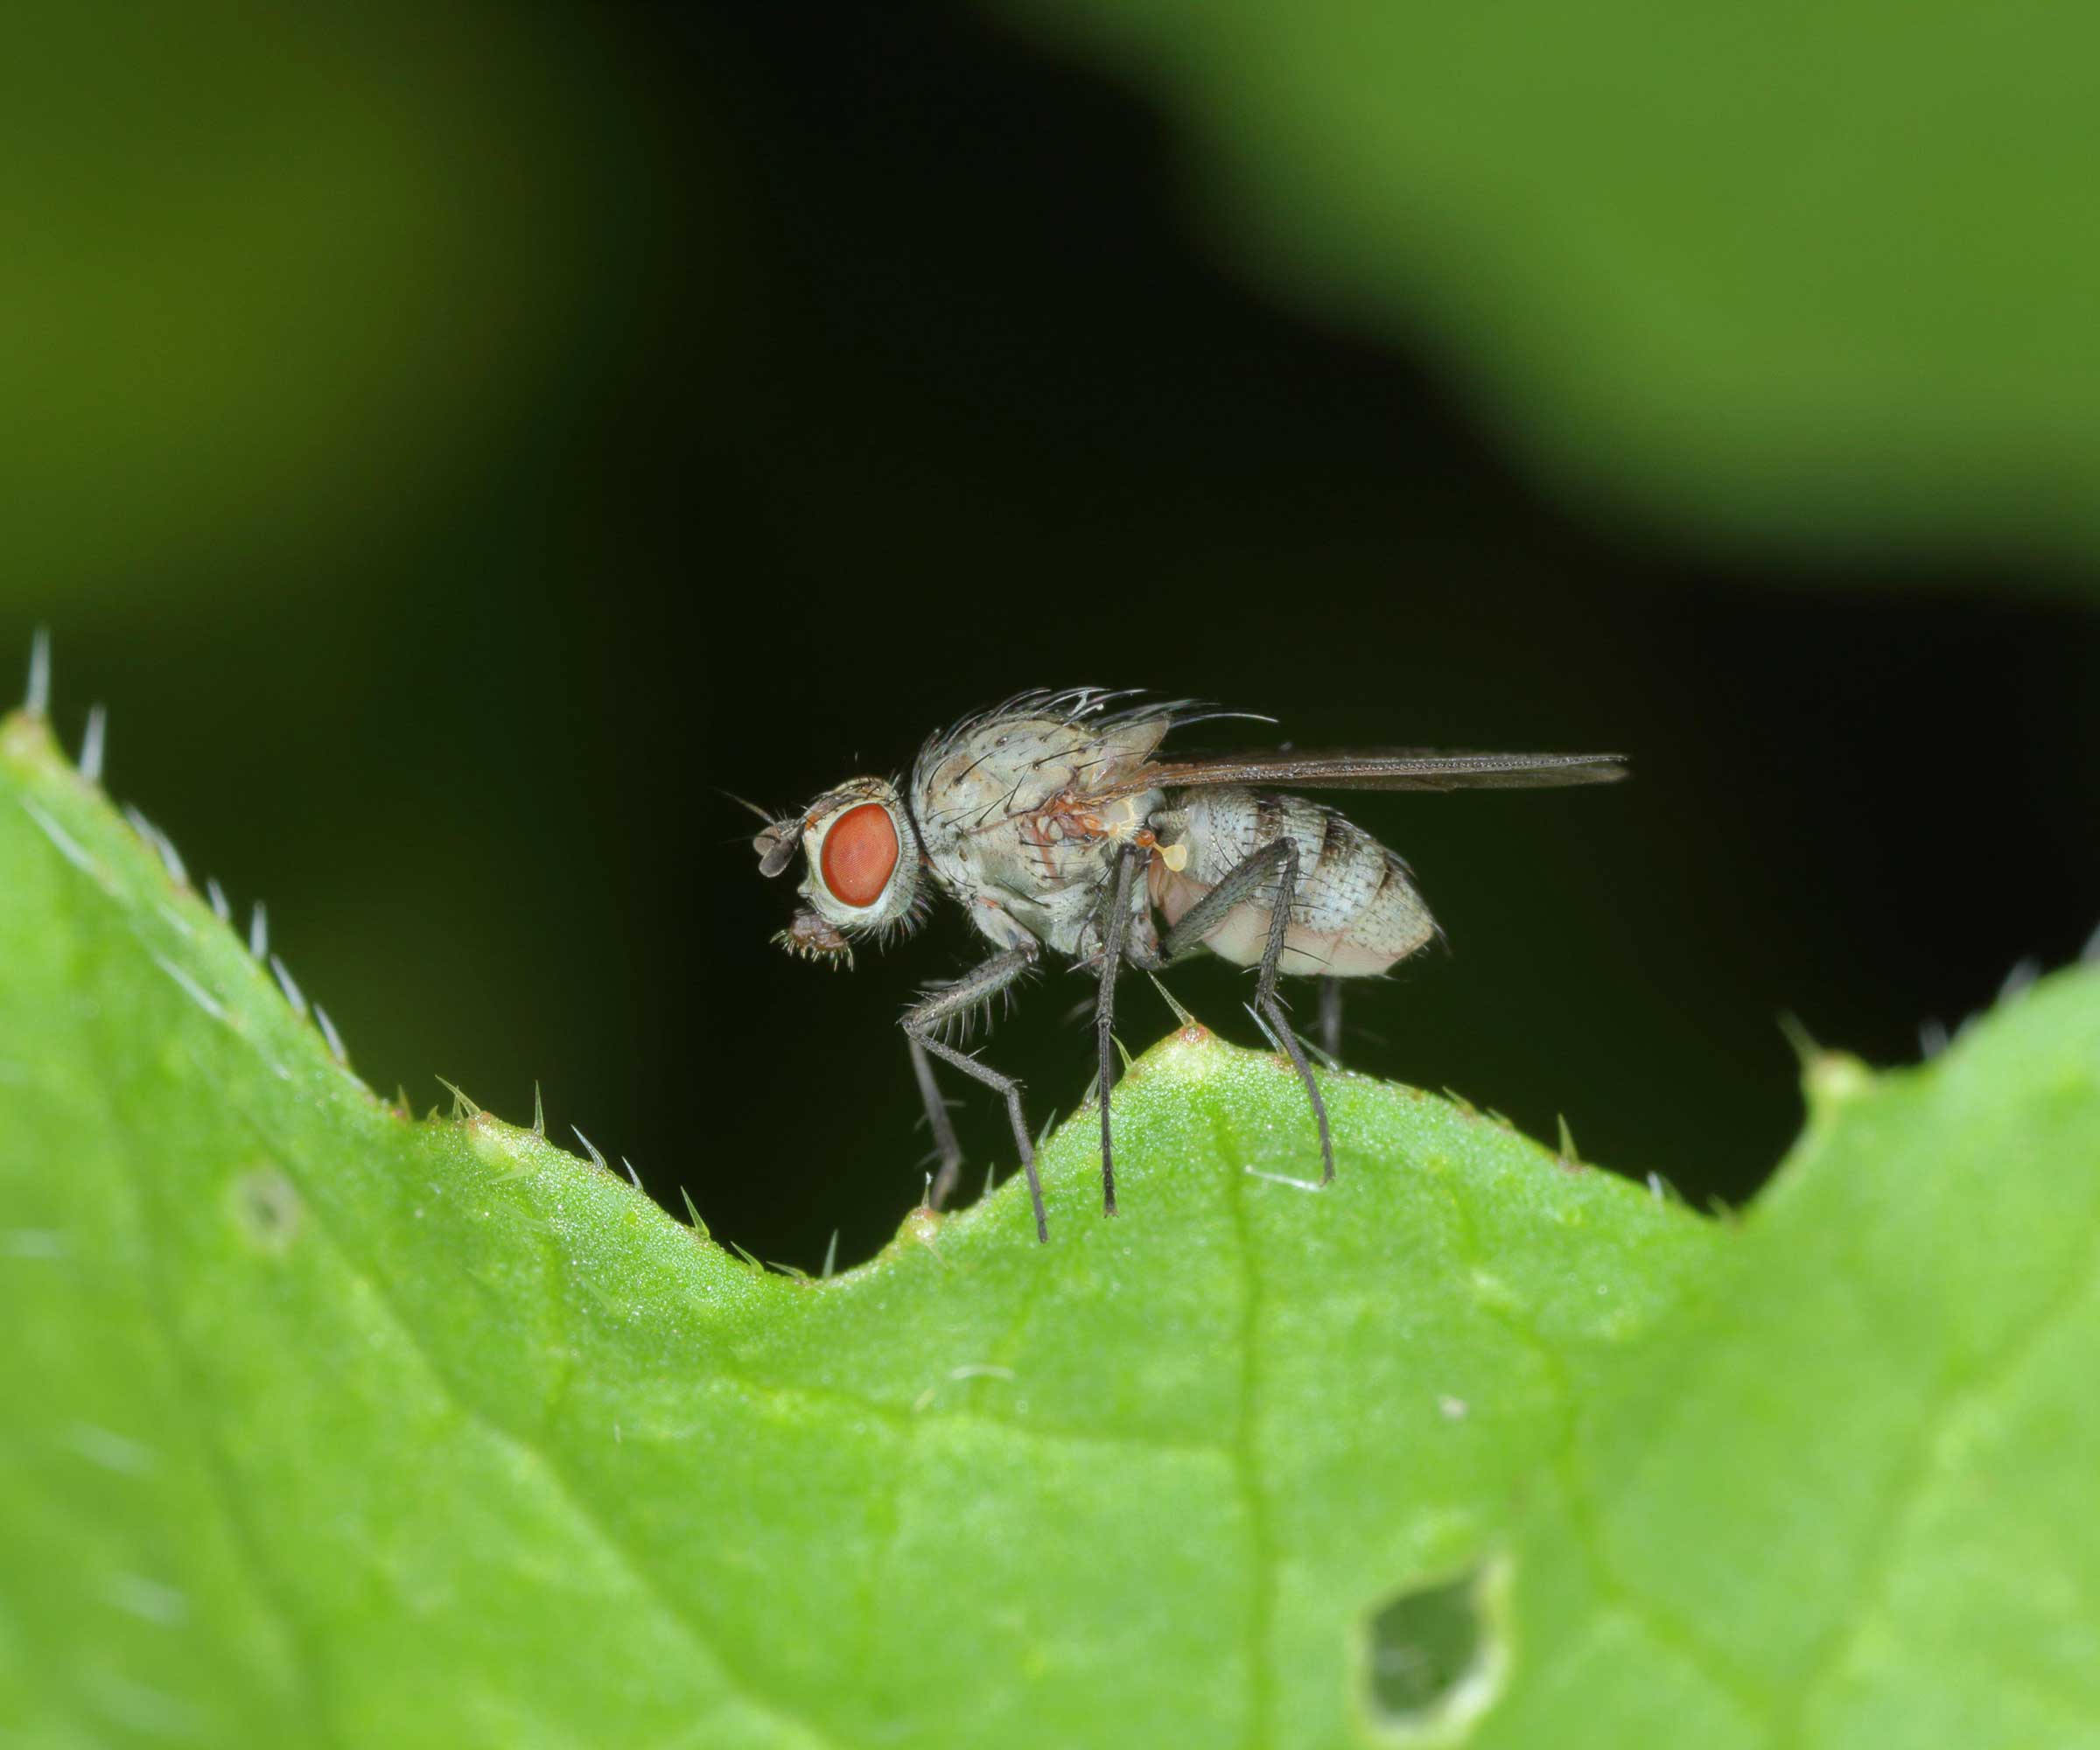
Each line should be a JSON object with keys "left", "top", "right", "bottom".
{"left": 1151, "top": 788, "right": 1437, "bottom": 979}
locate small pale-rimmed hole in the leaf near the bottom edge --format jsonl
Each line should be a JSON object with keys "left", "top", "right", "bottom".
{"left": 1361, "top": 1561, "right": 1510, "bottom": 1744}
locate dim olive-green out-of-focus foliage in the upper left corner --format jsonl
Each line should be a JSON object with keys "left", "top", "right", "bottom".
{"left": 0, "top": 2, "right": 638, "bottom": 628}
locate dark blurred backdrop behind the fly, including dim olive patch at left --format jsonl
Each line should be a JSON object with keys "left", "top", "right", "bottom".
{"left": 12, "top": 6, "right": 2100, "bottom": 1267}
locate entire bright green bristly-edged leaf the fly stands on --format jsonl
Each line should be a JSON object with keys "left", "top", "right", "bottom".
{"left": 0, "top": 701, "right": 2100, "bottom": 1748}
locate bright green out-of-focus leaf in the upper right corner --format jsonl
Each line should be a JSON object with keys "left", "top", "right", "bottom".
{"left": 998, "top": 0, "right": 2100, "bottom": 580}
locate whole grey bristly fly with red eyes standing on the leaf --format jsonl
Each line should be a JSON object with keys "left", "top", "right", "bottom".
{"left": 752, "top": 687, "right": 1626, "bottom": 1240}
